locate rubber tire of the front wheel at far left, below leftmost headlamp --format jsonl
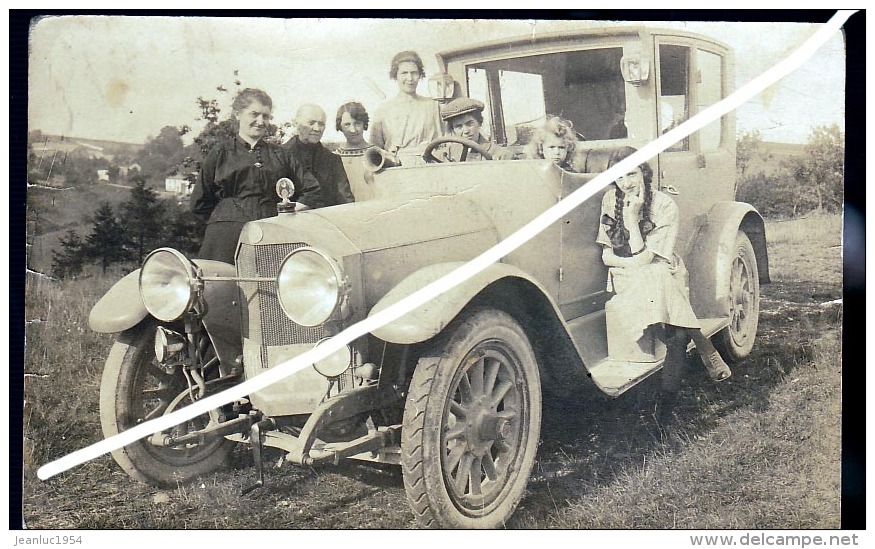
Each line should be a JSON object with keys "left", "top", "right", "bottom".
{"left": 100, "top": 321, "right": 234, "bottom": 488}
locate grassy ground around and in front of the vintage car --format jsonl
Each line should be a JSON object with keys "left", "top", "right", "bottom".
{"left": 23, "top": 216, "right": 842, "bottom": 529}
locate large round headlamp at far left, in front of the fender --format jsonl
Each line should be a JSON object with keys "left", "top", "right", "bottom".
{"left": 140, "top": 248, "right": 198, "bottom": 322}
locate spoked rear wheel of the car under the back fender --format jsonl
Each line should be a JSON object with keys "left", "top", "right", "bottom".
{"left": 713, "top": 231, "right": 760, "bottom": 363}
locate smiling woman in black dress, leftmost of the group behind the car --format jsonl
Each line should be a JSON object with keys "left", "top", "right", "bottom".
{"left": 191, "top": 88, "right": 322, "bottom": 263}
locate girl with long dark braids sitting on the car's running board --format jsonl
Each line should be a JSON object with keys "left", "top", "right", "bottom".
{"left": 596, "top": 147, "right": 732, "bottom": 412}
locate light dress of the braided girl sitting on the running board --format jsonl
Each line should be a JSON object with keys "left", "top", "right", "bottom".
{"left": 596, "top": 188, "right": 700, "bottom": 341}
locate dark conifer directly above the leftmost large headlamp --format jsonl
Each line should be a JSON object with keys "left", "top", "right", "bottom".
{"left": 121, "top": 179, "right": 164, "bottom": 263}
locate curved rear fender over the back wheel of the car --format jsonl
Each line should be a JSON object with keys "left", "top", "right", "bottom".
{"left": 684, "top": 202, "right": 770, "bottom": 318}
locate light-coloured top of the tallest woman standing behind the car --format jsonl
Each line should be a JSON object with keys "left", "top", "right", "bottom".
{"left": 369, "top": 95, "right": 442, "bottom": 154}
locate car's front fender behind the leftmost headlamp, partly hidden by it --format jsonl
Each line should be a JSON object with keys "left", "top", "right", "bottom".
{"left": 88, "top": 259, "right": 243, "bottom": 362}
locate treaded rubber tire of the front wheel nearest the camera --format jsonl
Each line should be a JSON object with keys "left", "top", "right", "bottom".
{"left": 401, "top": 309, "right": 542, "bottom": 529}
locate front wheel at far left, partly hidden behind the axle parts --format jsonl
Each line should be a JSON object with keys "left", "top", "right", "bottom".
{"left": 100, "top": 322, "right": 234, "bottom": 487}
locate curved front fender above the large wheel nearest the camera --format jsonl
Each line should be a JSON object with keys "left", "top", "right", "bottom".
{"left": 369, "top": 261, "right": 546, "bottom": 344}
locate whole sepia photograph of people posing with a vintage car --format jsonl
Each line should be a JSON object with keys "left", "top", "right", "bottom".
{"left": 22, "top": 11, "right": 863, "bottom": 531}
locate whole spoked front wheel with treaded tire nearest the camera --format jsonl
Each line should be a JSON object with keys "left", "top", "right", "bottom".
{"left": 401, "top": 309, "right": 541, "bottom": 528}
